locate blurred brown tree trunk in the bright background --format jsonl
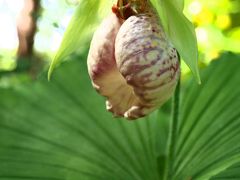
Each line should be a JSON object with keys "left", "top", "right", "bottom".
{"left": 17, "top": 0, "right": 41, "bottom": 74}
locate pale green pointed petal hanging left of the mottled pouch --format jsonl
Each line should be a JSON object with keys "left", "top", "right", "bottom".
{"left": 48, "top": 0, "right": 109, "bottom": 79}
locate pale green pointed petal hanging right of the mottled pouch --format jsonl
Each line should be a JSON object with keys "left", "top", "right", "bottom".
{"left": 153, "top": 0, "right": 201, "bottom": 83}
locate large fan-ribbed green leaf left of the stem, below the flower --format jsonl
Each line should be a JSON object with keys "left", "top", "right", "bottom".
{"left": 0, "top": 52, "right": 168, "bottom": 180}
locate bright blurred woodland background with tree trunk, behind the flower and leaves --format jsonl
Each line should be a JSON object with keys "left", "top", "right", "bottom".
{"left": 0, "top": 0, "right": 240, "bottom": 86}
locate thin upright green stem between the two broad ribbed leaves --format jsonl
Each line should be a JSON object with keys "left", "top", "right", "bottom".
{"left": 163, "top": 71, "right": 181, "bottom": 180}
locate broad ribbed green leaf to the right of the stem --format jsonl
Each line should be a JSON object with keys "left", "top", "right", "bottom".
{"left": 173, "top": 53, "right": 240, "bottom": 180}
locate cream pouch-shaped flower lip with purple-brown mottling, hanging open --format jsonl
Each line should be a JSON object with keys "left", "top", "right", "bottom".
{"left": 88, "top": 2, "right": 180, "bottom": 119}
